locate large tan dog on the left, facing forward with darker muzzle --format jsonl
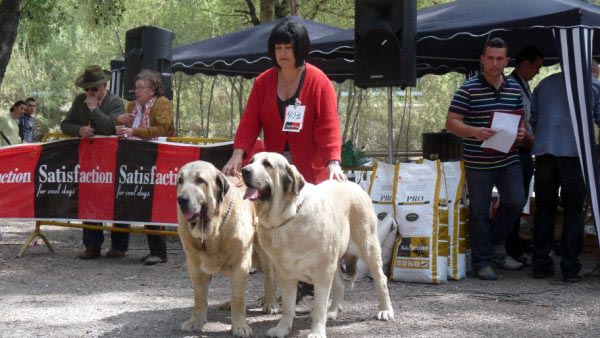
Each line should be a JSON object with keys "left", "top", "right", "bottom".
{"left": 177, "top": 161, "right": 279, "bottom": 337}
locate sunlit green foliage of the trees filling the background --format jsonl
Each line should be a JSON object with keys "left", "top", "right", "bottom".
{"left": 0, "top": 0, "right": 516, "bottom": 156}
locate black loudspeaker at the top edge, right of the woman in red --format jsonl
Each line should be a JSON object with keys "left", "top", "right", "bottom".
{"left": 354, "top": 0, "right": 417, "bottom": 88}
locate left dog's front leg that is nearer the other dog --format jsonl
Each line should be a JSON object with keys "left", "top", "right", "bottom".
{"left": 229, "top": 267, "right": 252, "bottom": 337}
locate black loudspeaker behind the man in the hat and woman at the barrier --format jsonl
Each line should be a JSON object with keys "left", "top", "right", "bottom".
{"left": 123, "top": 26, "right": 175, "bottom": 101}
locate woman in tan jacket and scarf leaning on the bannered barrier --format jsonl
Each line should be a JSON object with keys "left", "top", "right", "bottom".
{"left": 116, "top": 69, "right": 175, "bottom": 265}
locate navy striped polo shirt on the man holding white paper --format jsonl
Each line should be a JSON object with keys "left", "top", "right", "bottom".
{"left": 448, "top": 74, "right": 523, "bottom": 170}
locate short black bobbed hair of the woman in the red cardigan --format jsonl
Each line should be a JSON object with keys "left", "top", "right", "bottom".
{"left": 269, "top": 20, "right": 310, "bottom": 68}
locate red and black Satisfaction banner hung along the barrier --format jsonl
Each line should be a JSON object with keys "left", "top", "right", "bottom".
{"left": 0, "top": 137, "right": 233, "bottom": 225}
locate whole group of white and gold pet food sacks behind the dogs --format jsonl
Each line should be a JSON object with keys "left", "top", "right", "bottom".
{"left": 358, "top": 160, "right": 467, "bottom": 284}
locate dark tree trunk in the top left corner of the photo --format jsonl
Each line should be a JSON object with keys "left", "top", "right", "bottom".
{"left": 0, "top": 0, "right": 21, "bottom": 87}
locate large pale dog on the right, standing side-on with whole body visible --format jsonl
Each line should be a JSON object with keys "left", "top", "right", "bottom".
{"left": 242, "top": 153, "right": 394, "bottom": 337}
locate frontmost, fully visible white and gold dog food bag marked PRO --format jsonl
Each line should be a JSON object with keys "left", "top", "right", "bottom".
{"left": 391, "top": 160, "right": 448, "bottom": 284}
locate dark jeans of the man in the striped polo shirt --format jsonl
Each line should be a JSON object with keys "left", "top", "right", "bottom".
{"left": 466, "top": 163, "right": 525, "bottom": 270}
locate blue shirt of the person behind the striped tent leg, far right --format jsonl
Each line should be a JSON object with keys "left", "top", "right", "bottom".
{"left": 530, "top": 72, "right": 600, "bottom": 157}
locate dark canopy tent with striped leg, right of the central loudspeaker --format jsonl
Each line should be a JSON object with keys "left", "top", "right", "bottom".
{"left": 417, "top": 0, "right": 600, "bottom": 248}
